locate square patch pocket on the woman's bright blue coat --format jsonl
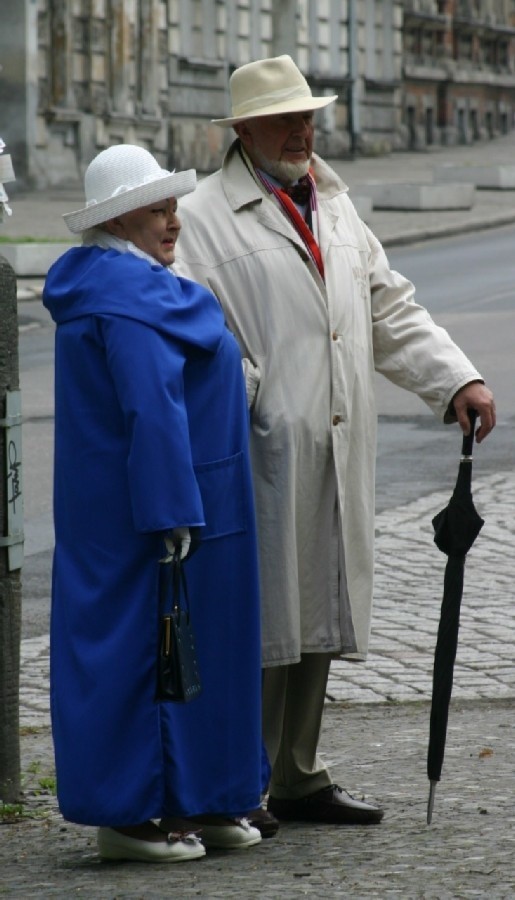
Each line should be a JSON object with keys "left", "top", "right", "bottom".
{"left": 195, "top": 452, "right": 247, "bottom": 541}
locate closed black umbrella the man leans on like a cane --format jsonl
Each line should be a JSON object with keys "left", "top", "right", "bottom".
{"left": 427, "top": 410, "right": 484, "bottom": 825}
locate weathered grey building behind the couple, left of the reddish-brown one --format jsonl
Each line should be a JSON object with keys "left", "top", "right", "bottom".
{"left": 0, "top": 0, "right": 402, "bottom": 186}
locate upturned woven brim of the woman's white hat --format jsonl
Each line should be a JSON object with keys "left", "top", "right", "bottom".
{"left": 63, "top": 169, "right": 197, "bottom": 234}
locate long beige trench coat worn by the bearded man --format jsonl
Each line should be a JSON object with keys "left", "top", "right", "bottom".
{"left": 174, "top": 141, "right": 481, "bottom": 665}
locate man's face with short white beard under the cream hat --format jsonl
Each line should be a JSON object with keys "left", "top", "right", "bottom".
{"left": 235, "top": 112, "right": 314, "bottom": 183}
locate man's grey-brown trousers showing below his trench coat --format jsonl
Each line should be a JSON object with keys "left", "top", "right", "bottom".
{"left": 263, "top": 653, "right": 332, "bottom": 800}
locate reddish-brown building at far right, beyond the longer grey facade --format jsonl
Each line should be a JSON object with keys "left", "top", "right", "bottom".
{"left": 403, "top": 0, "right": 515, "bottom": 149}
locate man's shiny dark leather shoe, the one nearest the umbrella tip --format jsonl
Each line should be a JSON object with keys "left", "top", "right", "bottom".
{"left": 268, "top": 784, "right": 384, "bottom": 825}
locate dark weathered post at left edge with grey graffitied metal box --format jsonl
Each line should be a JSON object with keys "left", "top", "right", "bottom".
{"left": 0, "top": 256, "right": 23, "bottom": 803}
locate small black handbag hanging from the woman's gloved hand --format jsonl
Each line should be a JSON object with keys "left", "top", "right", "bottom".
{"left": 154, "top": 554, "right": 202, "bottom": 703}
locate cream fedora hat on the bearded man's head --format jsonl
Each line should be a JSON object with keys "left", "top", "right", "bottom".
{"left": 211, "top": 54, "right": 337, "bottom": 127}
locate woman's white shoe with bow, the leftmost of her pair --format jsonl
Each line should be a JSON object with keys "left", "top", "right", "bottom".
{"left": 97, "top": 827, "right": 206, "bottom": 862}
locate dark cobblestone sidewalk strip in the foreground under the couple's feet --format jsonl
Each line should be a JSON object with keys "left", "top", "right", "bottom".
{"left": 0, "top": 700, "right": 515, "bottom": 900}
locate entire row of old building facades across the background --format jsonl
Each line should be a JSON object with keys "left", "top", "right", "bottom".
{"left": 0, "top": 0, "right": 515, "bottom": 187}
